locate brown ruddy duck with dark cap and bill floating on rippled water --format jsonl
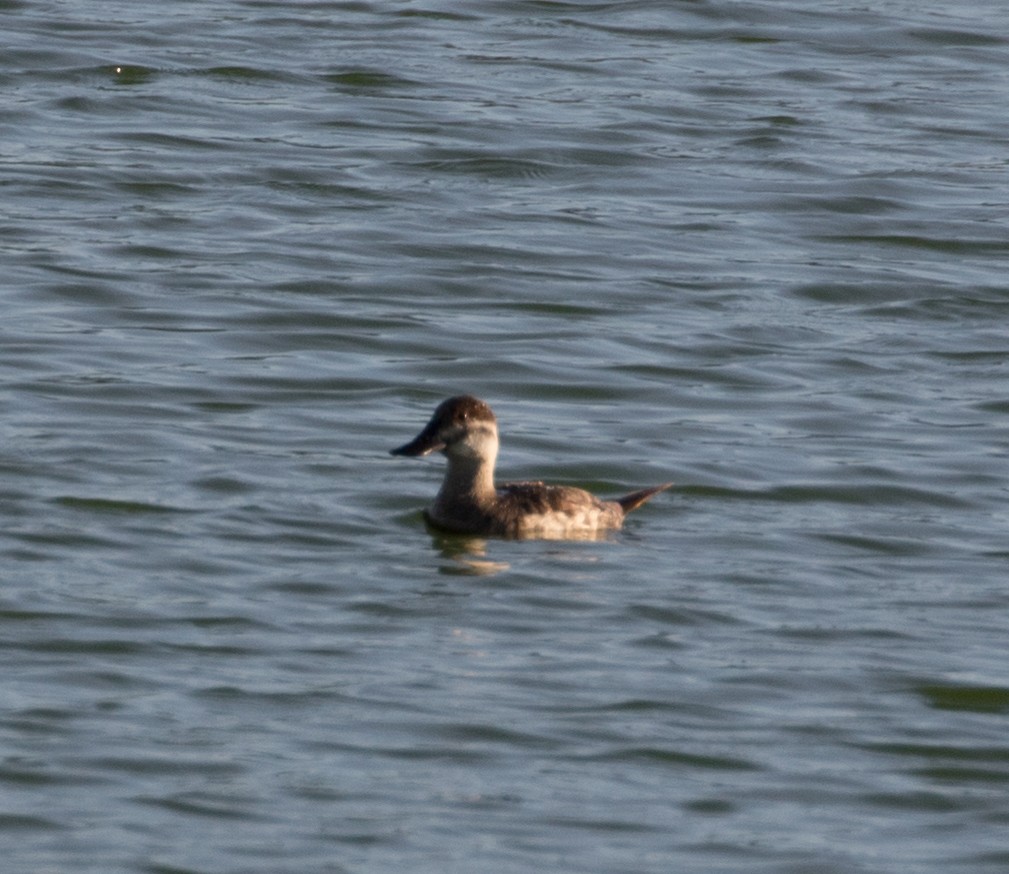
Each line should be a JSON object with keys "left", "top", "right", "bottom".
{"left": 390, "top": 395, "right": 672, "bottom": 540}
